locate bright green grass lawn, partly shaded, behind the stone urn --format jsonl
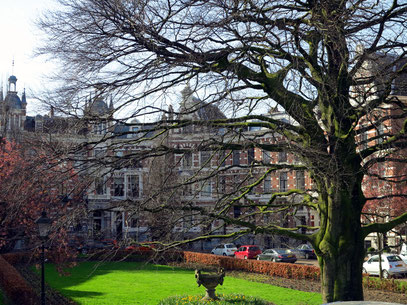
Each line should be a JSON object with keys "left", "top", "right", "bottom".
{"left": 41, "top": 262, "right": 322, "bottom": 305}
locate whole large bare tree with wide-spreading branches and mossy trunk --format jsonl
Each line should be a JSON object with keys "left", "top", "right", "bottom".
{"left": 38, "top": 0, "right": 407, "bottom": 302}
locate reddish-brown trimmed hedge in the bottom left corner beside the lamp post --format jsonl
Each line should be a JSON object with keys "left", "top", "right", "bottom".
{"left": 0, "top": 255, "right": 39, "bottom": 305}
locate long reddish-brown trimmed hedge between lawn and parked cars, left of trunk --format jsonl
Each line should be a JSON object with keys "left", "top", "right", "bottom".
{"left": 183, "top": 251, "right": 320, "bottom": 280}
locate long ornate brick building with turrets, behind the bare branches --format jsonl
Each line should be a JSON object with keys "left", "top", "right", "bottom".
{"left": 0, "top": 76, "right": 318, "bottom": 249}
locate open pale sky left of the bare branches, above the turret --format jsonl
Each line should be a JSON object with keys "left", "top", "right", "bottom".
{"left": 0, "top": 0, "right": 56, "bottom": 115}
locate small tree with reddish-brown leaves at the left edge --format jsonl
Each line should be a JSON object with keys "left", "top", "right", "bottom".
{"left": 0, "top": 141, "right": 86, "bottom": 262}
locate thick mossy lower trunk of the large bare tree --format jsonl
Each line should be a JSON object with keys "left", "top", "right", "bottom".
{"left": 316, "top": 172, "right": 364, "bottom": 302}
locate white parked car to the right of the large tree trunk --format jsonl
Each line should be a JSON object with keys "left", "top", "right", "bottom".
{"left": 362, "top": 253, "right": 407, "bottom": 279}
